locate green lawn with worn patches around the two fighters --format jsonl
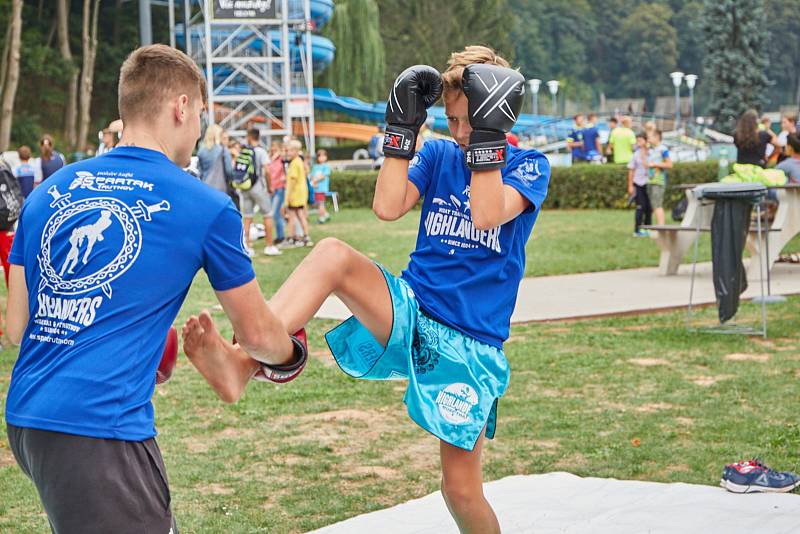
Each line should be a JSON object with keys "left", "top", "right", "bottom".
{"left": 0, "top": 210, "right": 800, "bottom": 534}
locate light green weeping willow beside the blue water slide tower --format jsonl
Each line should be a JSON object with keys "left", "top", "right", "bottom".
{"left": 320, "top": 0, "right": 385, "bottom": 101}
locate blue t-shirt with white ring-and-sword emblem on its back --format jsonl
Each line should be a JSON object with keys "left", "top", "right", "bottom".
{"left": 6, "top": 146, "right": 255, "bottom": 441}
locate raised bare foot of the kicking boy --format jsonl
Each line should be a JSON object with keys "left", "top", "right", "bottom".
{"left": 181, "top": 311, "right": 260, "bottom": 402}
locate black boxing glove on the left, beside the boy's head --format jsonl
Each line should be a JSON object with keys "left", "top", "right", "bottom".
{"left": 383, "top": 65, "right": 442, "bottom": 159}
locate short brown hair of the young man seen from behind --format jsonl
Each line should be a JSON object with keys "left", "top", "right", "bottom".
{"left": 117, "top": 44, "right": 206, "bottom": 124}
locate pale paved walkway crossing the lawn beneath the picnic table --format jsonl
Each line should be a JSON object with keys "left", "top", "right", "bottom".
{"left": 317, "top": 263, "right": 800, "bottom": 323}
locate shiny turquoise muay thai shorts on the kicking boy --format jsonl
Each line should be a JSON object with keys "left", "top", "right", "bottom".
{"left": 325, "top": 265, "right": 510, "bottom": 450}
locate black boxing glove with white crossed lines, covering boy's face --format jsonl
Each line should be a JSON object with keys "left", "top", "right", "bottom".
{"left": 462, "top": 64, "right": 525, "bottom": 171}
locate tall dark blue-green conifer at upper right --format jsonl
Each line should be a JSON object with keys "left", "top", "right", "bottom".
{"left": 702, "top": 0, "right": 770, "bottom": 131}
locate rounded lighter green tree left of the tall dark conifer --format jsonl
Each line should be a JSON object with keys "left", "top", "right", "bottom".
{"left": 617, "top": 4, "right": 678, "bottom": 98}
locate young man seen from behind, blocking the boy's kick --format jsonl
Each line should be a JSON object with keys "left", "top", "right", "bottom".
{"left": 5, "top": 45, "right": 298, "bottom": 534}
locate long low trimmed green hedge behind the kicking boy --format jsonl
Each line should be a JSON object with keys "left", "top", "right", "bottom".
{"left": 331, "top": 161, "right": 717, "bottom": 210}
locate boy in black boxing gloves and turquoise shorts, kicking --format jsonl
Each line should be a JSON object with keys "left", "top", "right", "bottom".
{"left": 187, "top": 46, "right": 550, "bottom": 533}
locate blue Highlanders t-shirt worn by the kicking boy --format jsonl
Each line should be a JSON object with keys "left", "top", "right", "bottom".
{"left": 402, "top": 139, "right": 550, "bottom": 348}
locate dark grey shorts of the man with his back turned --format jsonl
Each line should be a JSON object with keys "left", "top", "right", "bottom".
{"left": 7, "top": 424, "right": 178, "bottom": 534}
